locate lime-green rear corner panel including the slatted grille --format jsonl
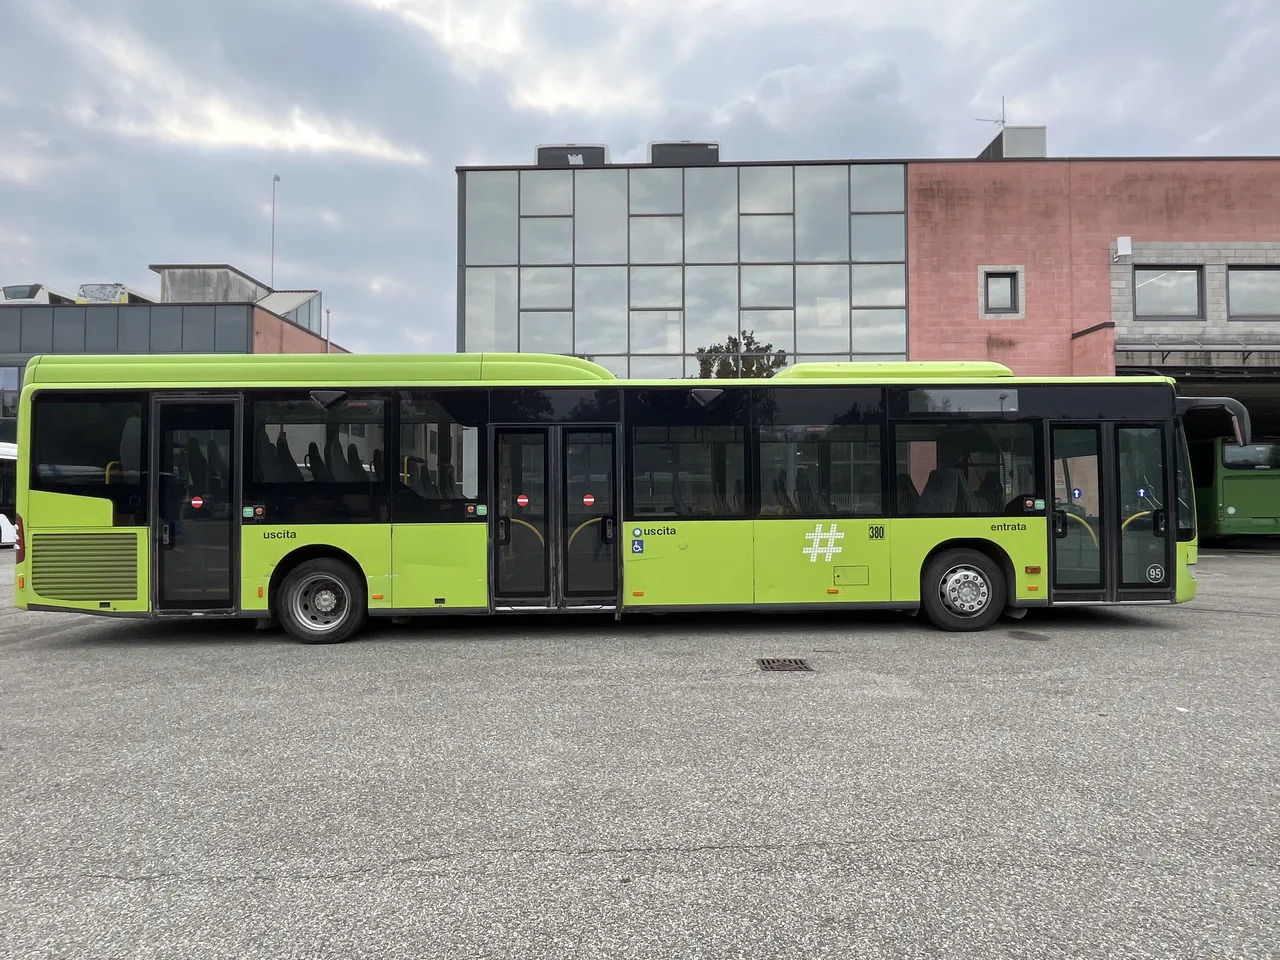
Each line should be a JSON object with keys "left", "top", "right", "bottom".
{"left": 14, "top": 490, "right": 151, "bottom": 613}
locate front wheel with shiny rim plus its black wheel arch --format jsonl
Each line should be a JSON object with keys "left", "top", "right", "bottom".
{"left": 920, "top": 538, "right": 1016, "bottom": 632}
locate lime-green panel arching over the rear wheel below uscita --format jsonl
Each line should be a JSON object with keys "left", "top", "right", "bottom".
{"left": 241, "top": 524, "right": 392, "bottom": 613}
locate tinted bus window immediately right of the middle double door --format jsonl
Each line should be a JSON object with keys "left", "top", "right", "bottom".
{"left": 627, "top": 389, "right": 748, "bottom": 518}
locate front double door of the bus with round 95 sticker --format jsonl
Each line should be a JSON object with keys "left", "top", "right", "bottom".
{"left": 1050, "top": 422, "right": 1176, "bottom": 603}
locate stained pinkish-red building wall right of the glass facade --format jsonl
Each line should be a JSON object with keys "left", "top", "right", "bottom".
{"left": 908, "top": 159, "right": 1280, "bottom": 375}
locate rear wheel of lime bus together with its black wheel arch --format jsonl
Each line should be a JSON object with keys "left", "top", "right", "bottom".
{"left": 268, "top": 547, "right": 369, "bottom": 644}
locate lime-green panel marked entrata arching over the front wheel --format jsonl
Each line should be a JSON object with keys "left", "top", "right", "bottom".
{"left": 888, "top": 516, "right": 1050, "bottom": 603}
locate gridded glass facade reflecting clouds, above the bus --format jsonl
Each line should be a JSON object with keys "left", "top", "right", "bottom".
{"left": 458, "top": 163, "right": 908, "bottom": 378}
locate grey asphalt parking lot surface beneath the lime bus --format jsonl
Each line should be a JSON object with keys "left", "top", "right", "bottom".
{"left": 0, "top": 550, "right": 1280, "bottom": 959}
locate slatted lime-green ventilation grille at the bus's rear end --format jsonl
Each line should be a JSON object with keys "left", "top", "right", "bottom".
{"left": 31, "top": 534, "right": 138, "bottom": 602}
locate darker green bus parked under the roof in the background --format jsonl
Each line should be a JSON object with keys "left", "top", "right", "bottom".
{"left": 1189, "top": 436, "right": 1280, "bottom": 538}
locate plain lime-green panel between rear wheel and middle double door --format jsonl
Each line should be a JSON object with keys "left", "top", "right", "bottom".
{"left": 390, "top": 522, "right": 489, "bottom": 611}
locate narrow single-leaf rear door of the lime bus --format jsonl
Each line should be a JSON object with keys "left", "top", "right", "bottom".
{"left": 151, "top": 397, "right": 241, "bottom": 614}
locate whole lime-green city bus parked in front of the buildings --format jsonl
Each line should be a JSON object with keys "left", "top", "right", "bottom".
{"left": 15, "top": 353, "right": 1248, "bottom": 643}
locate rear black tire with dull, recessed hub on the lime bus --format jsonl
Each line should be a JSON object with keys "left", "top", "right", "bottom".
{"left": 275, "top": 558, "right": 367, "bottom": 644}
